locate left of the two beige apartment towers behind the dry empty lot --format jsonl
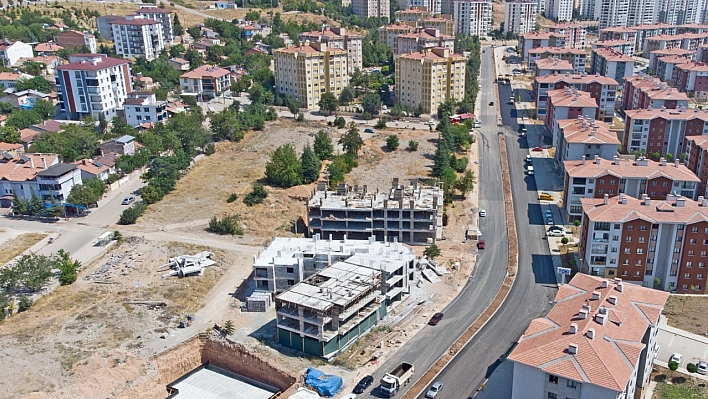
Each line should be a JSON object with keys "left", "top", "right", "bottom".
{"left": 273, "top": 43, "right": 349, "bottom": 109}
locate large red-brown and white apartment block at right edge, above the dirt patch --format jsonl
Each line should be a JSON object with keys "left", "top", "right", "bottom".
{"left": 579, "top": 193, "right": 708, "bottom": 295}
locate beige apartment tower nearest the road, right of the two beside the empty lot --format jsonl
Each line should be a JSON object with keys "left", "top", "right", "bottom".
{"left": 395, "top": 47, "right": 466, "bottom": 114}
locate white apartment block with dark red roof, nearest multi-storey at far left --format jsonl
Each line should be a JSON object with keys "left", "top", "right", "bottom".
{"left": 55, "top": 54, "right": 133, "bottom": 120}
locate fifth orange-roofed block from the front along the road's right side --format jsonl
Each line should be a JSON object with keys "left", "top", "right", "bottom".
{"left": 545, "top": 87, "right": 598, "bottom": 131}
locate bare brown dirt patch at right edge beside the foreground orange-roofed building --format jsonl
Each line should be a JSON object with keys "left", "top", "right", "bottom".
{"left": 663, "top": 295, "right": 708, "bottom": 335}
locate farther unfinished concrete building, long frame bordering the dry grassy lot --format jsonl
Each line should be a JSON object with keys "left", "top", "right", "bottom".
{"left": 307, "top": 179, "right": 443, "bottom": 244}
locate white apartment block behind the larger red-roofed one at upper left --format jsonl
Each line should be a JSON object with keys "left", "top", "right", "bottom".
{"left": 110, "top": 15, "right": 165, "bottom": 61}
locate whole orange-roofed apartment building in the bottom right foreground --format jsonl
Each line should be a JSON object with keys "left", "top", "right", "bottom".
{"left": 508, "top": 273, "right": 668, "bottom": 399}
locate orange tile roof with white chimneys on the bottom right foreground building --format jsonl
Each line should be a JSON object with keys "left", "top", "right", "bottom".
{"left": 509, "top": 273, "right": 669, "bottom": 392}
